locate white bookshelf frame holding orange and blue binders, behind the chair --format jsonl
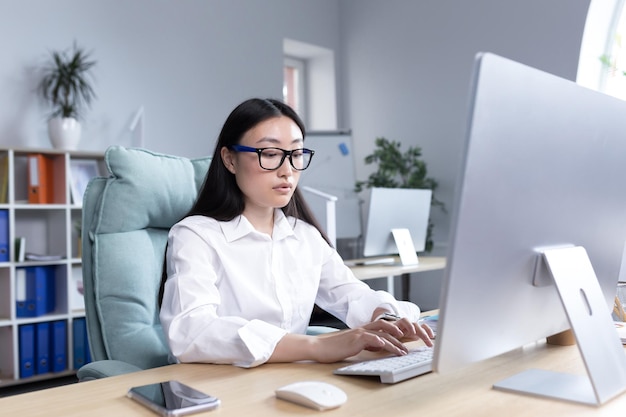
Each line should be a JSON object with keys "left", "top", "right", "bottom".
{"left": 0, "top": 148, "right": 106, "bottom": 388}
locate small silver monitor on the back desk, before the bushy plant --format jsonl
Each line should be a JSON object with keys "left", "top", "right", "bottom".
{"left": 363, "top": 187, "right": 432, "bottom": 264}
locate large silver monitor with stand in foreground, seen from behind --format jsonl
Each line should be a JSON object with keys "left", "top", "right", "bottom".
{"left": 433, "top": 54, "right": 626, "bottom": 404}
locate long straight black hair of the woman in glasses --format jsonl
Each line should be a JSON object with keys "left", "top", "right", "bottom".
{"left": 159, "top": 98, "right": 330, "bottom": 306}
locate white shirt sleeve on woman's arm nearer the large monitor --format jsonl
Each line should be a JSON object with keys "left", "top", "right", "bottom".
{"left": 316, "top": 242, "right": 420, "bottom": 328}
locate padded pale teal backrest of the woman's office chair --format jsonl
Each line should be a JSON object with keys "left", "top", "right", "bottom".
{"left": 82, "top": 146, "right": 210, "bottom": 369}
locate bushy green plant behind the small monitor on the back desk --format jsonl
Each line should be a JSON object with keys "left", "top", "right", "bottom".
{"left": 355, "top": 137, "right": 446, "bottom": 252}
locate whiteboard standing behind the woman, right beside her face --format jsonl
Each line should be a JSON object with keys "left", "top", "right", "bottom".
{"left": 300, "top": 130, "right": 362, "bottom": 239}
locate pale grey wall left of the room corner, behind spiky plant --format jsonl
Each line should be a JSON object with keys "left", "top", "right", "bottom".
{"left": 0, "top": 0, "right": 339, "bottom": 156}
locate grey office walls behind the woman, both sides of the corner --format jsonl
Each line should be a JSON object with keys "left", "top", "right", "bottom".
{"left": 0, "top": 0, "right": 590, "bottom": 308}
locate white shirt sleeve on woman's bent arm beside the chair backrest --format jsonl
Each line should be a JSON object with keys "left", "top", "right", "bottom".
{"left": 160, "top": 221, "right": 287, "bottom": 367}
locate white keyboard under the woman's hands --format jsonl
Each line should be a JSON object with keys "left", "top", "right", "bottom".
{"left": 333, "top": 347, "right": 433, "bottom": 384}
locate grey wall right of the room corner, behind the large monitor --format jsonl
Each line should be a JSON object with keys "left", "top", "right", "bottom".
{"left": 339, "top": 0, "right": 589, "bottom": 309}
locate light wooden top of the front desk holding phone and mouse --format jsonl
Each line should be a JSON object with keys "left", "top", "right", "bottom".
{"left": 0, "top": 343, "right": 626, "bottom": 417}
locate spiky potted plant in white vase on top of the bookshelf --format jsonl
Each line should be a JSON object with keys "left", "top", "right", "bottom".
{"left": 38, "top": 44, "right": 96, "bottom": 149}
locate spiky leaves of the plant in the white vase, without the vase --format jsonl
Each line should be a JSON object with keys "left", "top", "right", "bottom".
{"left": 38, "top": 44, "right": 96, "bottom": 119}
